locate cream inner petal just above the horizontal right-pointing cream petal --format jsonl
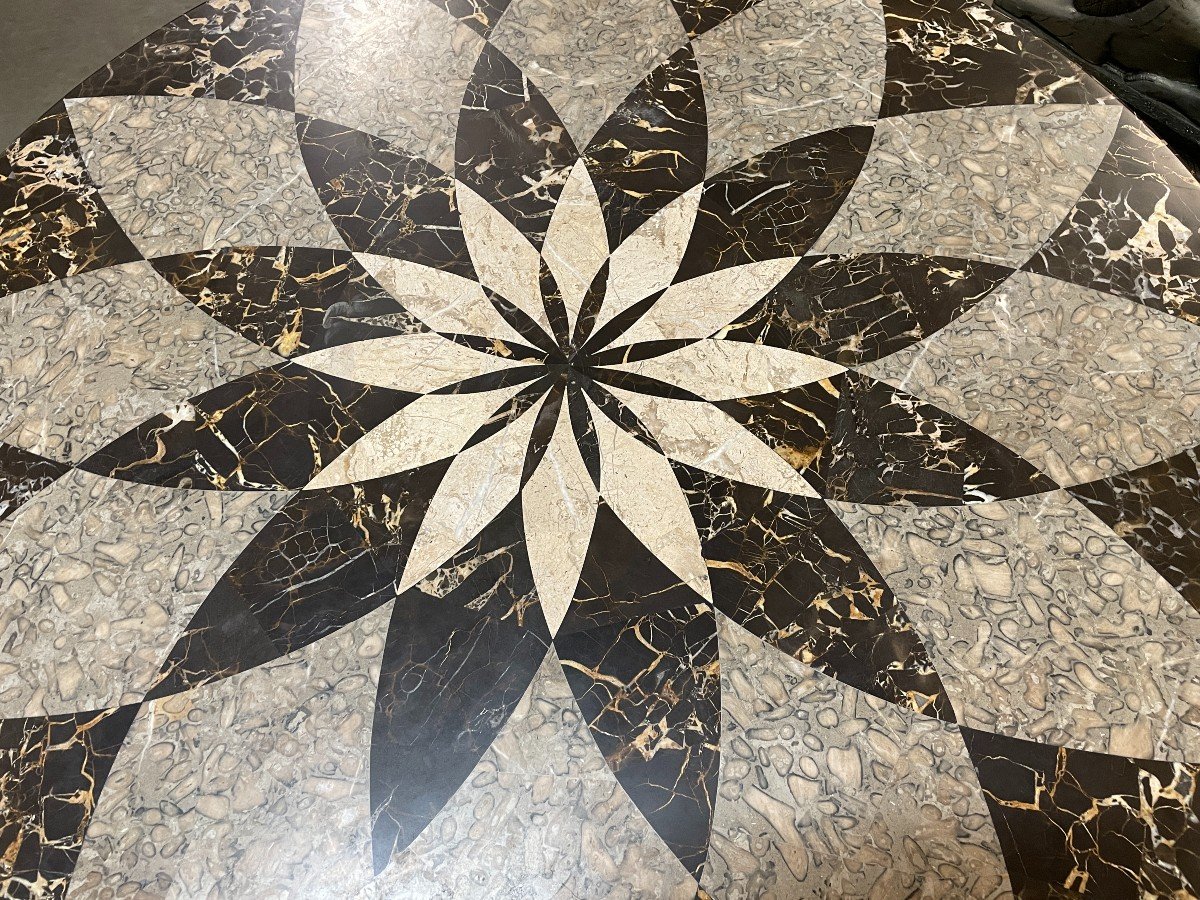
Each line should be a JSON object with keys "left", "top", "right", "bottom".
{"left": 617, "top": 257, "right": 796, "bottom": 346}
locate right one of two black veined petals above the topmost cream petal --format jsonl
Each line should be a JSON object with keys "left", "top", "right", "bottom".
{"left": 583, "top": 44, "right": 708, "bottom": 250}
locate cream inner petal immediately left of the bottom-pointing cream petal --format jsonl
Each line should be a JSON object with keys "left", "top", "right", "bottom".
{"left": 400, "top": 401, "right": 541, "bottom": 590}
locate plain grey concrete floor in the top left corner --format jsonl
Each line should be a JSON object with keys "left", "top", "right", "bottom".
{"left": 0, "top": 0, "right": 199, "bottom": 148}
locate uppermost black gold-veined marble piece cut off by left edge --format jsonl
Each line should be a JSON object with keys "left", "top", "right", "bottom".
{"left": 0, "top": 103, "right": 142, "bottom": 296}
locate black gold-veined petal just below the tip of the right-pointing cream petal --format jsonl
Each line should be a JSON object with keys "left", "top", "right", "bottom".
{"left": 716, "top": 372, "right": 1058, "bottom": 506}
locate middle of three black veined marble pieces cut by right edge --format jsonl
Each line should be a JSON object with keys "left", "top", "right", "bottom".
{"left": 1068, "top": 448, "right": 1200, "bottom": 610}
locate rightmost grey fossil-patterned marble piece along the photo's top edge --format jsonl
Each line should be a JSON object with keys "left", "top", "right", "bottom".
{"left": 692, "top": 0, "right": 887, "bottom": 174}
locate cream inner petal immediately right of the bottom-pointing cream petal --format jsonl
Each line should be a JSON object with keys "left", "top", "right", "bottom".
{"left": 588, "top": 401, "right": 713, "bottom": 600}
